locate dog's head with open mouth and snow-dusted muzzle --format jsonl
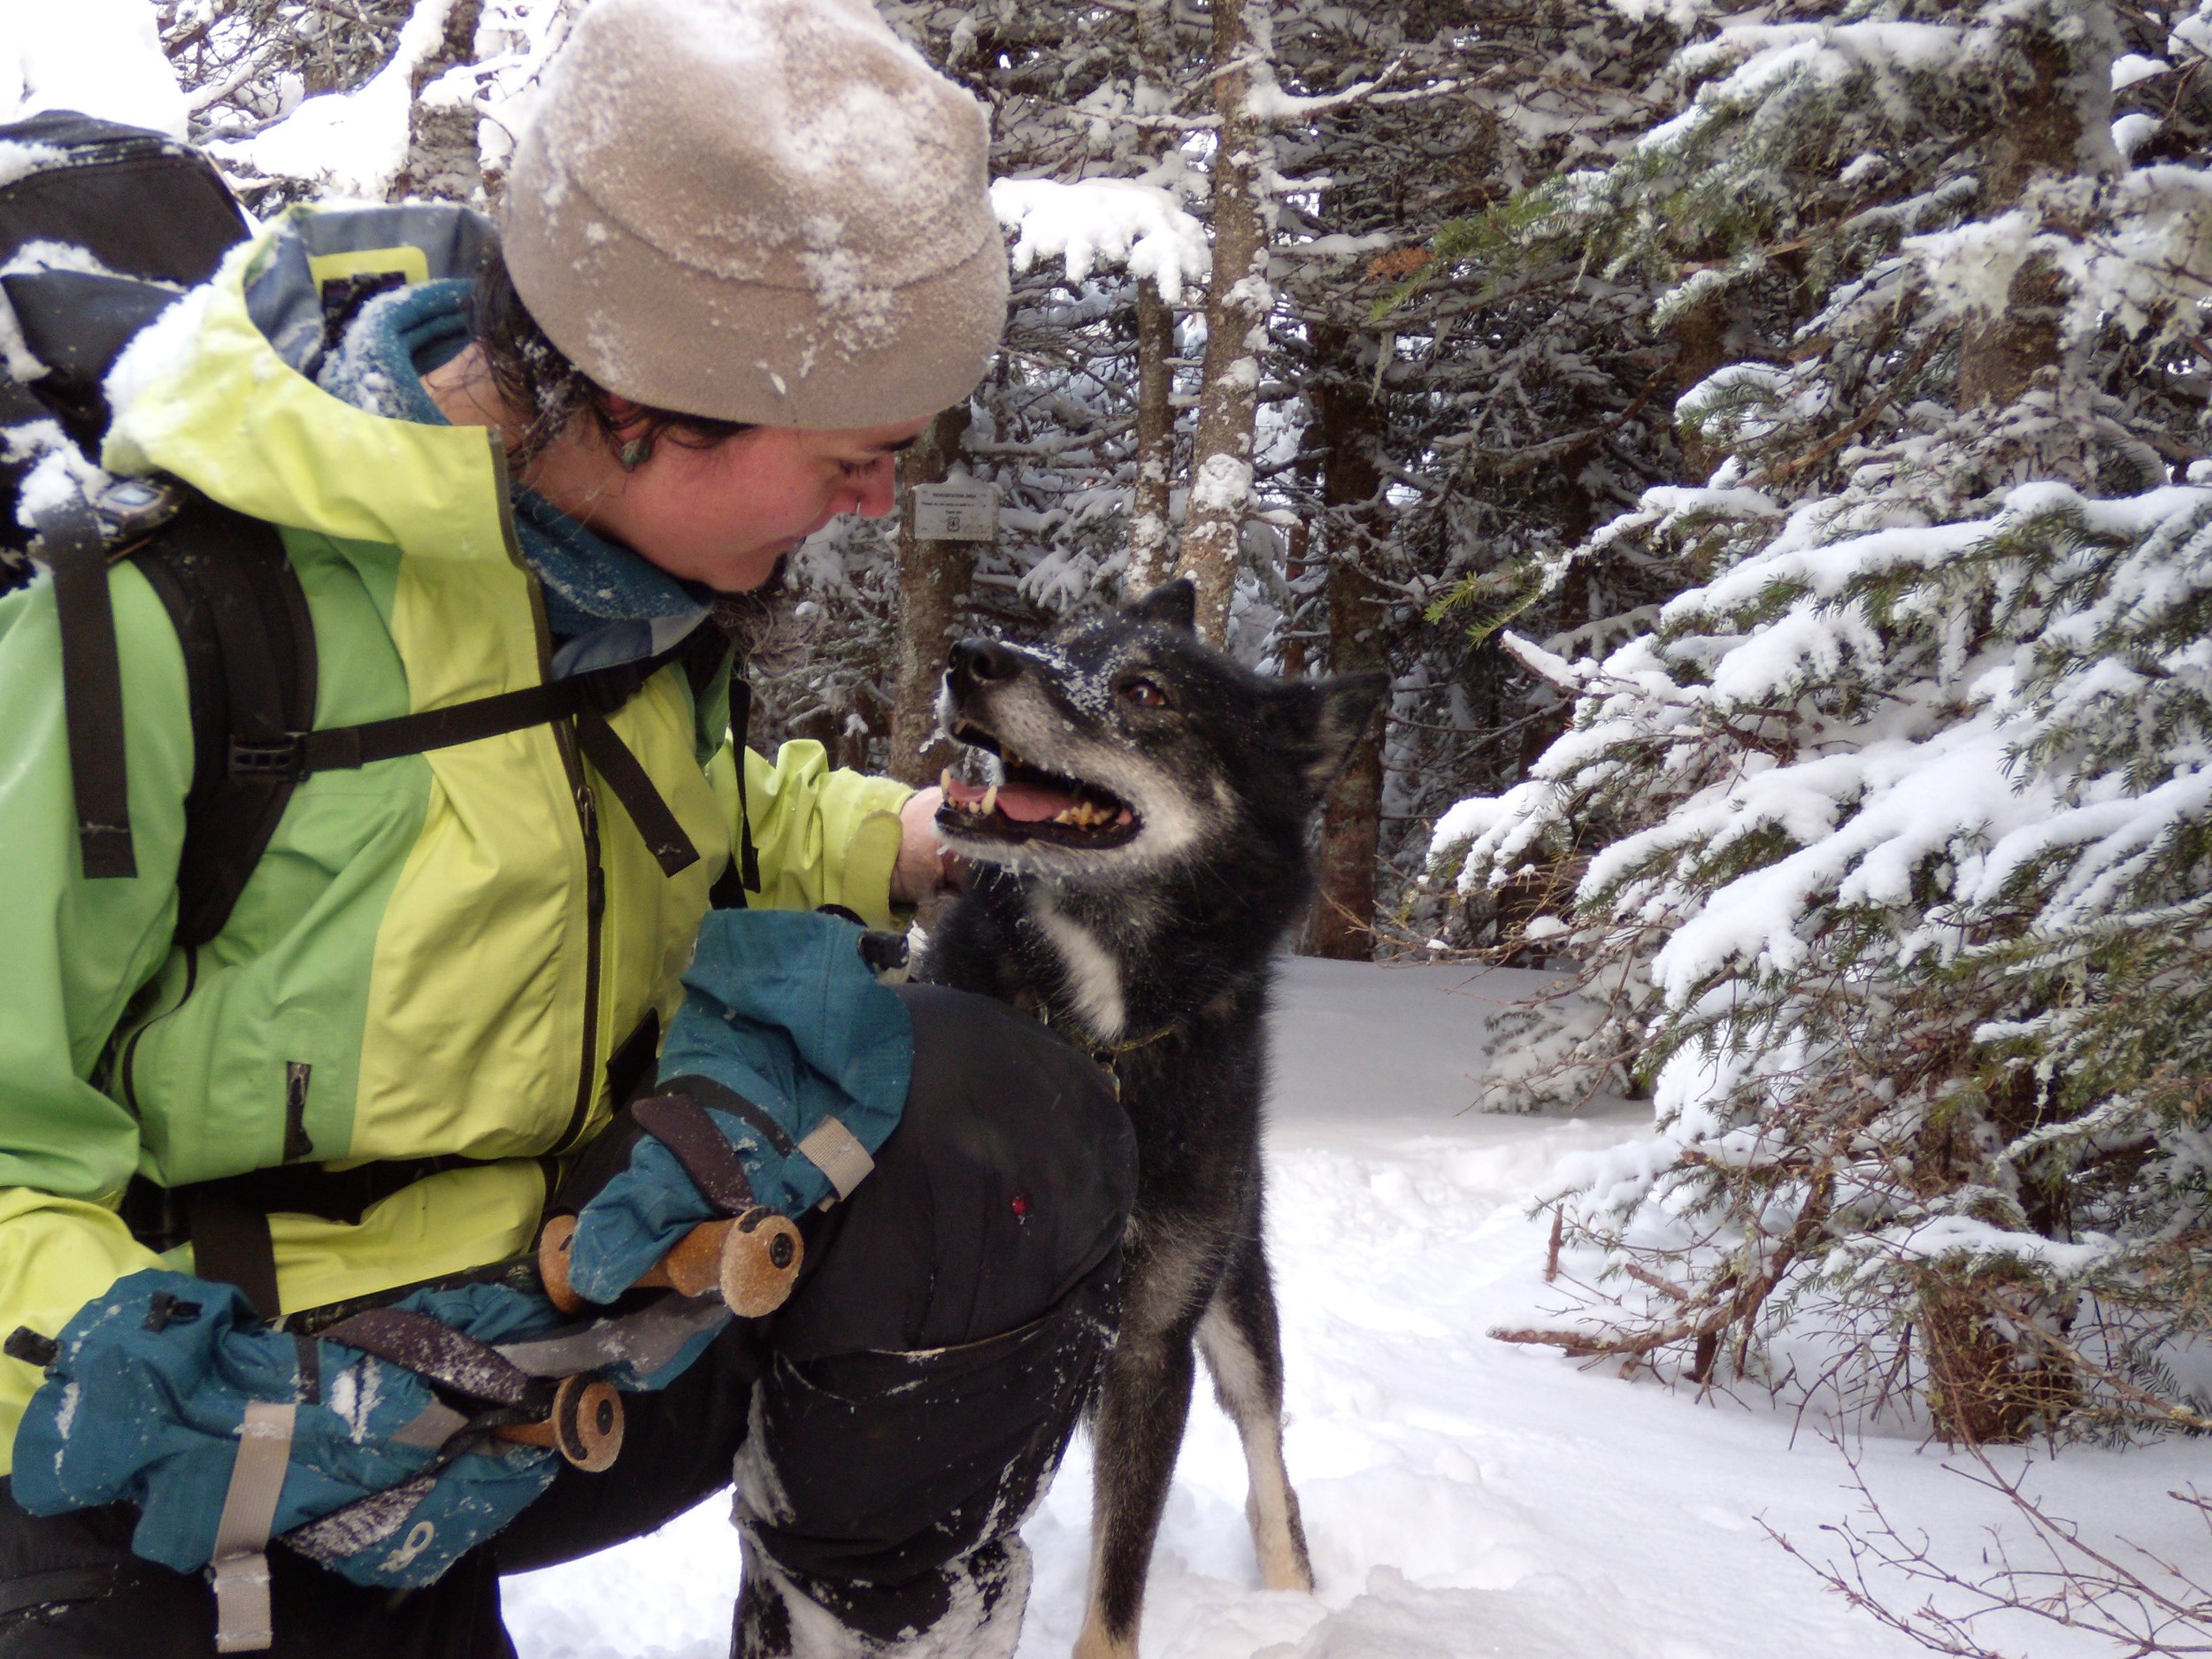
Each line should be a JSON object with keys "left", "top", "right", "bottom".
{"left": 938, "top": 582, "right": 1385, "bottom": 879}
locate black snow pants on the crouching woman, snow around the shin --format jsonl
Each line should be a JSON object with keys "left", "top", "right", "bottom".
{"left": 0, "top": 987, "right": 1137, "bottom": 1659}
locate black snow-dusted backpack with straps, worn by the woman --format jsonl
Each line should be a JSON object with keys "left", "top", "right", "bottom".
{"left": 0, "top": 111, "right": 761, "bottom": 1317}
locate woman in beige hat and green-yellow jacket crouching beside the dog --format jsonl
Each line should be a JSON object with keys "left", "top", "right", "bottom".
{"left": 0, "top": 0, "right": 1133, "bottom": 1659}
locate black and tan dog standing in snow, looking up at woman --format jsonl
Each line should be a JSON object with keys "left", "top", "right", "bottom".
{"left": 918, "top": 582, "right": 1385, "bottom": 1659}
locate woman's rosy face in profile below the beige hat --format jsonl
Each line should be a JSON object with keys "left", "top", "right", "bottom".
{"left": 566, "top": 420, "right": 929, "bottom": 593}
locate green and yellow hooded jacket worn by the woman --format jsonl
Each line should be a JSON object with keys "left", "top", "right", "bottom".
{"left": 0, "top": 211, "right": 907, "bottom": 1478}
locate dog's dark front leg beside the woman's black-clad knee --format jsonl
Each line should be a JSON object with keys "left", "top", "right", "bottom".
{"left": 1075, "top": 1310, "right": 1197, "bottom": 1659}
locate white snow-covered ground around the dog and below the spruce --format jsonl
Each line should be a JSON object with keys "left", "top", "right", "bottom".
{"left": 507, "top": 960, "right": 2212, "bottom": 1659}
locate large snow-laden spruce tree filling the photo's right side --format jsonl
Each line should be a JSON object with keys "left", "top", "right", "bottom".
{"left": 1438, "top": 0, "right": 2212, "bottom": 1440}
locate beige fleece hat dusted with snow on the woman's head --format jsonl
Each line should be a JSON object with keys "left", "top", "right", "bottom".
{"left": 503, "top": 0, "right": 1007, "bottom": 427}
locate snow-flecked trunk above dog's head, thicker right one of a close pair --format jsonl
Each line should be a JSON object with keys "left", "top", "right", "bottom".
{"left": 1181, "top": 0, "right": 1274, "bottom": 646}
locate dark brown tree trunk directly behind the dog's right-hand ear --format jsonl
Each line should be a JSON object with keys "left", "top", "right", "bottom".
{"left": 1305, "top": 327, "right": 1389, "bottom": 963}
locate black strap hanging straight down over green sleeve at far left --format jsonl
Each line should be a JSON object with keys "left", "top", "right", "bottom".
{"left": 35, "top": 489, "right": 137, "bottom": 880}
